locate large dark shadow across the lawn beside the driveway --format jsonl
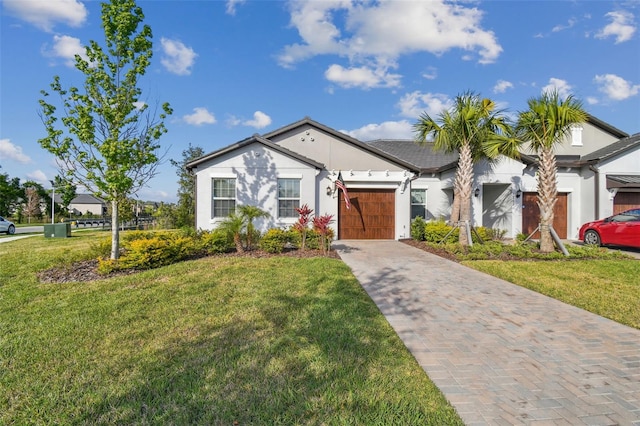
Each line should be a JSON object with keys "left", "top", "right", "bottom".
{"left": 81, "top": 275, "right": 457, "bottom": 424}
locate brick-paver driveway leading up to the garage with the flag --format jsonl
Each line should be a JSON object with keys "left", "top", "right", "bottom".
{"left": 334, "top": 241, "right": 640, "bottom": 426}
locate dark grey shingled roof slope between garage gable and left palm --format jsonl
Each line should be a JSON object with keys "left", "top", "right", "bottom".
{"left": 367, "top": 139, "right": 458, "bottom": 173}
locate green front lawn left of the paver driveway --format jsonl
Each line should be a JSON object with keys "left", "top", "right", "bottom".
{"left": 0, "top": 232, "right": 462, "bottom": 425}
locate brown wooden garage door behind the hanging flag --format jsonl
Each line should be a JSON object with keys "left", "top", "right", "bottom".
{"left": 338, "top": 188, "right": 396, "bottom": 240}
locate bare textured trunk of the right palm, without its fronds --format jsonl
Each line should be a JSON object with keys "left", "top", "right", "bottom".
{"left": 537, "top": 148, "right": 558, "bottom": 253}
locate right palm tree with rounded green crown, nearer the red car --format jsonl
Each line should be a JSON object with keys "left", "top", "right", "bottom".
{"left": 516, "top": 90, "right": 587, "bottom": 253}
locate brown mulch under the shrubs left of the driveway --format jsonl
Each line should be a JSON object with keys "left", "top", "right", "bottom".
{"left": 37, "top": 250, "right": 340, "bottom": 284}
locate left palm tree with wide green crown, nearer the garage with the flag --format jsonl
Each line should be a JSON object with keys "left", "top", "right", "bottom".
{"left": 413, "top": 92, "right": 509, "bottom": 246}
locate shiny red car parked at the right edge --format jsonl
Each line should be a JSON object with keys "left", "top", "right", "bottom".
{"left": 579, "top": 209, "right": 640, "bottom": 248}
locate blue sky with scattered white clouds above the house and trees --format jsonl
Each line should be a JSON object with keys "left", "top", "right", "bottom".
{"left": 0, "top": 0, "right": 640, "bottom": 202}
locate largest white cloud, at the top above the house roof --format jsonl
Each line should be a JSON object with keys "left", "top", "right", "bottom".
{"left": 278, "top": 0, "right": 502, "bottom": 67}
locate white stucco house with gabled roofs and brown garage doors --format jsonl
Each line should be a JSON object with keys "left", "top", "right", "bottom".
{"left": 187, "top": 117, "right": 640, "bottom": 239}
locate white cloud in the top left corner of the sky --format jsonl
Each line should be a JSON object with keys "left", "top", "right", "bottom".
{"left": 3, "top": 0, "right": 88, "bottom": 32}
